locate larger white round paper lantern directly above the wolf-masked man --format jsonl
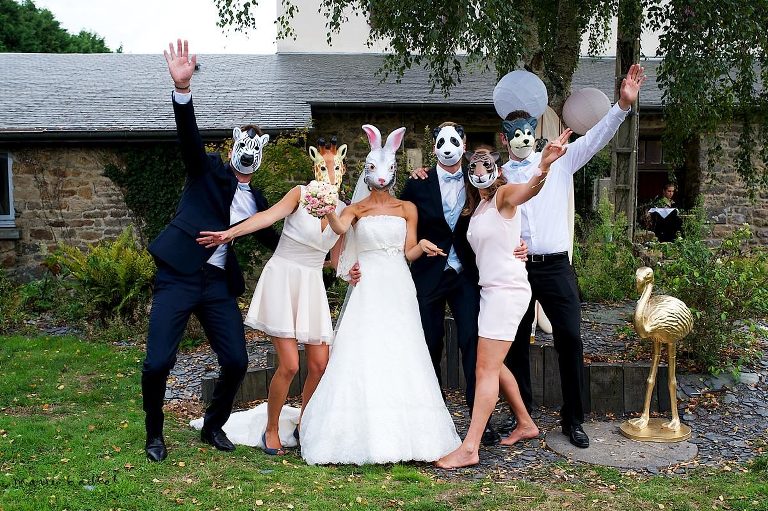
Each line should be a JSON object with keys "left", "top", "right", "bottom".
{"left": 493, "top": 69, "right": 548, "bottom": 119}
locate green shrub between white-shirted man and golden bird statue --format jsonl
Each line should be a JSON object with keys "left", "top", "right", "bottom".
{"left": 573, "top": 198, "right": 638, "bottom": 302}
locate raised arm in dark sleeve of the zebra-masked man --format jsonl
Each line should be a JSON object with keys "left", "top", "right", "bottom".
{"left": 163, "top": 39, "right": 206, "bottom": 175}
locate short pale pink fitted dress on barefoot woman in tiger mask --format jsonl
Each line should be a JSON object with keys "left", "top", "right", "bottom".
{"left": 467, "top": 194, "right": 531, "bottom": 341}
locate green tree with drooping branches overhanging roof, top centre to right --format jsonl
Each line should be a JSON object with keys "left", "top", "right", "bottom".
{"left": 213, "top": 0, "right": 768, "bottom": 192}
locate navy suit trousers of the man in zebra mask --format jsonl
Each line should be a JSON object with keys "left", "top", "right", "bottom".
{"left": 141, "top": 262, "right": 248, "bottom": 436}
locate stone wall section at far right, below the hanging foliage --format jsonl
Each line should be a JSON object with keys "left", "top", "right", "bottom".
{"left": 698, "top": 126, "right": 768, "bottom": 244}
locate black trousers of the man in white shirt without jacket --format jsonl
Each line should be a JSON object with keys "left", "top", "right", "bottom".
{"left": 505, "top": 258, "right": 584, "bottom": 426}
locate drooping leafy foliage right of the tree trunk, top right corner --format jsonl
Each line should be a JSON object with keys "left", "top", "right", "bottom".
{"left": 647, "top": 0, "right": 768, "bottom": 193}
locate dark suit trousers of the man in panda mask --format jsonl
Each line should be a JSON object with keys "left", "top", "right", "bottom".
{"left": 418, "top": 269, "right": 480, "bottom": 413}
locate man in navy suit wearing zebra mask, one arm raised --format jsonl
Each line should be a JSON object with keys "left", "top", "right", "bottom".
{"left": 141, "top": 39, "right": 279, "bottom": 461}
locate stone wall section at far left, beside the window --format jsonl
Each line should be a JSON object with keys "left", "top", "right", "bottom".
{"left": 0, "top": 145, "right": 133, "bottom": 278}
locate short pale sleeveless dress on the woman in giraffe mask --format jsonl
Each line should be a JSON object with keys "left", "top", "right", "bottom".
{"left": 245, "top": 186, "right": 344, "bottom": 344}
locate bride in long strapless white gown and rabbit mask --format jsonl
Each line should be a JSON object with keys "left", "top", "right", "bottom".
{"left": 301, "top": 125, "right": 461, "bottom": 465}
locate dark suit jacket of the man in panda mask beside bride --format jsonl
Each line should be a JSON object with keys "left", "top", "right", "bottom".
{"left": 400, "top": 167, "right": 478, "bottom": 299}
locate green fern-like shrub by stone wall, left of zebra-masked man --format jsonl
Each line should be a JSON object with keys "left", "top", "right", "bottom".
{"left": 53, "top": 227, "right": 155, "bottom": 322}
